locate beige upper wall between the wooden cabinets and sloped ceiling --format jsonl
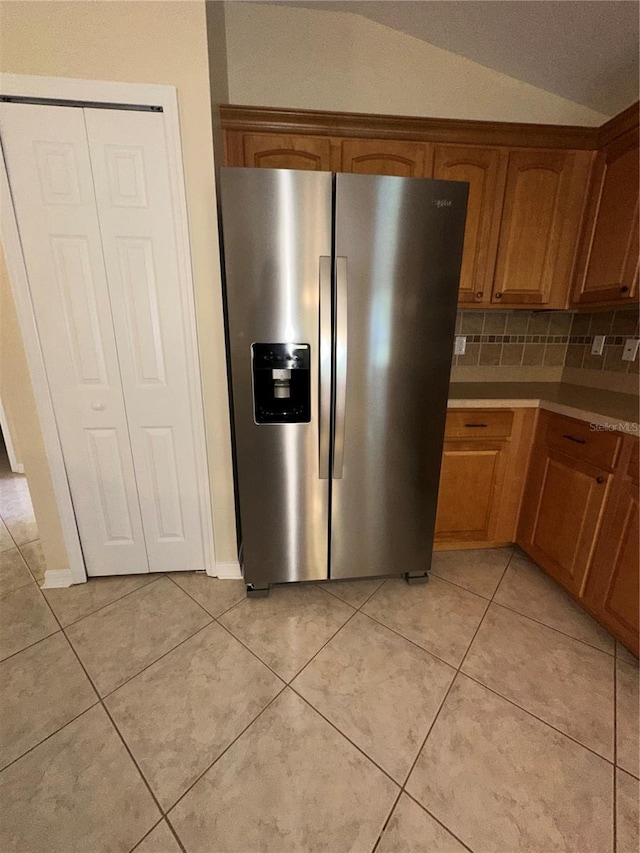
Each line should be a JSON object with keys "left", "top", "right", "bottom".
{"left": 225, "top": 2, "right": 608, "bottom": 125}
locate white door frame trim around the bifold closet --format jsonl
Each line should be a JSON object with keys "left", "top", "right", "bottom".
{"left": 0, "top": 73, "right": 217, "bottom": 588}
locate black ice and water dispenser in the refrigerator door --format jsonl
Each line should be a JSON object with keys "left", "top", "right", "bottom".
{"left": 251, "top": 343, "right": 311, "bottom": 424}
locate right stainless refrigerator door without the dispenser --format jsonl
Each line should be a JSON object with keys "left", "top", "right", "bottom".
{"left": 330, "top": 175, "right": 467, "bottom": 578}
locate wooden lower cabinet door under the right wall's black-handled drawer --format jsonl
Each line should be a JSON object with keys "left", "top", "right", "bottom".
{"left": 518, "top": 442, "right": 612, "bottom": 597}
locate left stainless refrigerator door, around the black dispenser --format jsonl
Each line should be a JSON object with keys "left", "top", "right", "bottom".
{"left": 221, "top": 168, "right": 332, "bottom": 586}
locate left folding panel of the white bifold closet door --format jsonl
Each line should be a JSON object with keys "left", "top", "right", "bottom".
{"left": 0, "top": 104, "right": 149, "bottom": 575}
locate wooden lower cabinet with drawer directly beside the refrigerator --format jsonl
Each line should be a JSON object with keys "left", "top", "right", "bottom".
{"left": 435, "top": 409, "right": 535, "bottom": 550}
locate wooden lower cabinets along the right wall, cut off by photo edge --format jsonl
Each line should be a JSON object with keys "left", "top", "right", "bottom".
{"left": 516, "top": 412, "right": 640, "bottom": 655}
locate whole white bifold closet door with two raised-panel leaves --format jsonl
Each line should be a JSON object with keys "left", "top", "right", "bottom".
{"left": 0, "top": 104, "right": 204, "bottom": 575}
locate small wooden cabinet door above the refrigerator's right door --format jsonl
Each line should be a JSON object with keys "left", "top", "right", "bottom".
{"left": 341, "top": 139, "right": 428, "bottom": 178}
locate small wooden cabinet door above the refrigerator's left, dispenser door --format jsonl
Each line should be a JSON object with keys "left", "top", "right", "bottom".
{"left": 242, "top": 133, "right": 331, "bottom": 172}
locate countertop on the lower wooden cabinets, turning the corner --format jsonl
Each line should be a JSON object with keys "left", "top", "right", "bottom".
{"left": 448, "top": 382, "right": 639, "bottom": 435}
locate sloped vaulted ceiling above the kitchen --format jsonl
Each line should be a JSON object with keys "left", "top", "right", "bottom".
{"left": 262, "top": 0, "right": 640, "bottom": 115}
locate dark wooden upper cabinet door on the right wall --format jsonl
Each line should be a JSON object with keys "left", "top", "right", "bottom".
{"left": 575, "top": 134, "right": 640, "bottom": 304}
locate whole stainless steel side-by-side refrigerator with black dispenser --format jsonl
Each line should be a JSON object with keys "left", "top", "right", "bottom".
{"left": 221, "top": 168, "right": 468, "bottom": 594}
